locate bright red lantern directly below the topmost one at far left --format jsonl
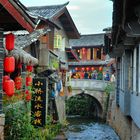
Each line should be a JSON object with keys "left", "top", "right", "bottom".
{"left": 4, "top": 56, "right": 15, "bottom": 72}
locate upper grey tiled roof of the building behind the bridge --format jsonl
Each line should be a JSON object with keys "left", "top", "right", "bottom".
{"left": 70, "top": 33, "right": 104, "bottom": 48}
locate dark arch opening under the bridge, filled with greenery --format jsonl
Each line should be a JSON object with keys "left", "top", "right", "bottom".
{"left": 66, "top": 93, "right": 103, "bottom": 119}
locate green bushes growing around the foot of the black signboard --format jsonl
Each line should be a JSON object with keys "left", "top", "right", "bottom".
{"left": 4, "top": 104, "right": 61, "bottom": 140}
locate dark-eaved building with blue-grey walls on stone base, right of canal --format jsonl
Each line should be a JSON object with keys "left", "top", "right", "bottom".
{"left": 106, "top": 0, "right": 140, "bottom": 140}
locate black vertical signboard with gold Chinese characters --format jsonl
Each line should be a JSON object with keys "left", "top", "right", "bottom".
{"left": 31, "top": 78, "right": 46, "bottom": 127}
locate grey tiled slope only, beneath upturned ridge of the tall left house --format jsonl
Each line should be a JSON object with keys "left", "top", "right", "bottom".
{"left": 28, "top": 3, "right": 68, "bottom": 19}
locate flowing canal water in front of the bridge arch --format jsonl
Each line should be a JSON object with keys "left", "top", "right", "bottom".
{"left": 65, "top": 118, "right": 120, "bottom": 140}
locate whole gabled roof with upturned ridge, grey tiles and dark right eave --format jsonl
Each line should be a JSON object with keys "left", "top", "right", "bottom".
{"left": 28, "top": 2, "right": 80, "bottom": 39}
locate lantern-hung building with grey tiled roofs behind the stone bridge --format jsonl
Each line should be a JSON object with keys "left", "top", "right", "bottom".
{"left": 66, "top": 34, "right": 114, "bottom": 77}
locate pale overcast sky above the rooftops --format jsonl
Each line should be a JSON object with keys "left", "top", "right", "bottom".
{"left": 20, "top": 0, "right": 112, "bottom": 34}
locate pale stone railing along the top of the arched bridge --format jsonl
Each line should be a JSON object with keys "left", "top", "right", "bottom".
{"left": 71, "top": 79, "right": 108, "bottom": 91}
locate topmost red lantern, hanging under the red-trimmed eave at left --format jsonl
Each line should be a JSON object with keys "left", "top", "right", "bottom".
{"left": 5, "top": 33, "right": 15, "bottom": 51}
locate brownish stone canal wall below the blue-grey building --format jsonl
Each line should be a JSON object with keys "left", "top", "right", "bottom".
{"left": 108, "top": 100, "right": 140, "bottom": 140}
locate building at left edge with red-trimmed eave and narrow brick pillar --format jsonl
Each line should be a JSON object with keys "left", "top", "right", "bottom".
{"left": 0, "top": 0, "right": 39, "bottom": 140}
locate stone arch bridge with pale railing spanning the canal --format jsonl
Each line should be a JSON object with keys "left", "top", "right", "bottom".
{"left": 67, "top": 79, "right": 108, "bottom": 118}
